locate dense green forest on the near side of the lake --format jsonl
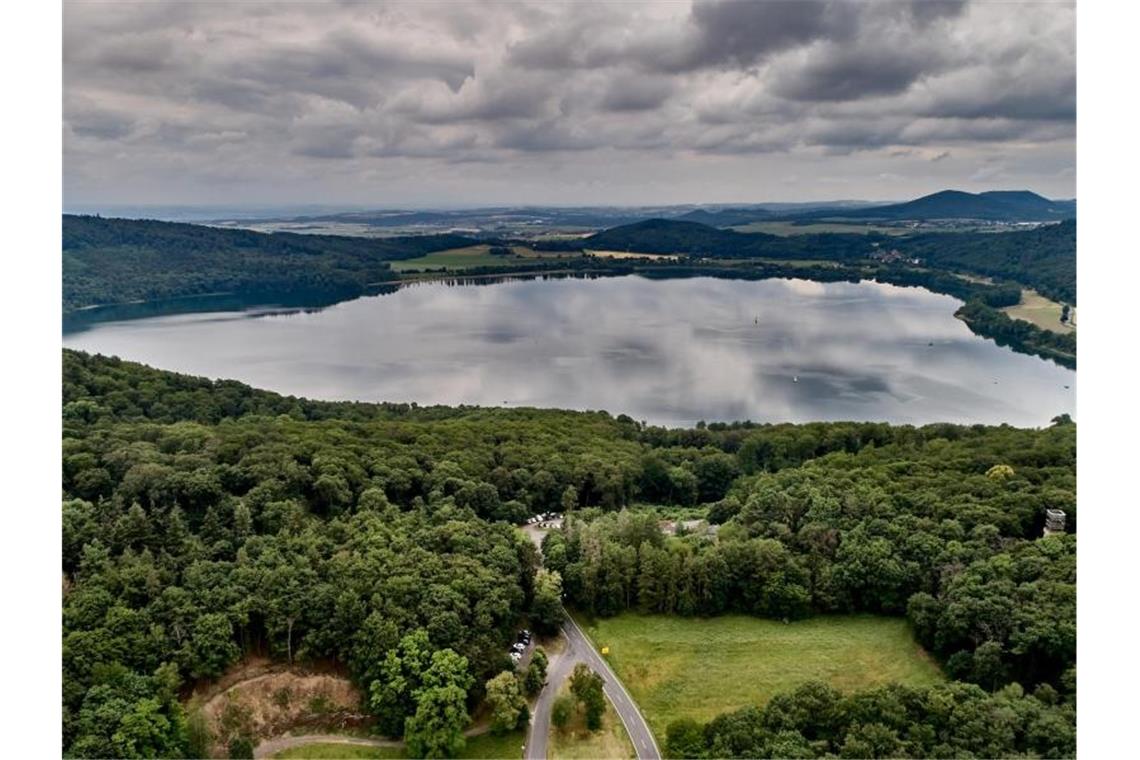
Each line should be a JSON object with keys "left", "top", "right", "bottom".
{"left": 62, "top": 351, "right": 1076, "bottom": 757}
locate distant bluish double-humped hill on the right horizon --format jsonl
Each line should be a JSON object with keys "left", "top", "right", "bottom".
{"left": 792, "top": 190, "right": 1076, "bottom": 222}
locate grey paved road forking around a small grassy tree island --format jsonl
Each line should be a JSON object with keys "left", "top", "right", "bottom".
{"left": 523, "top": 615, "right": 661, "bottom": 760}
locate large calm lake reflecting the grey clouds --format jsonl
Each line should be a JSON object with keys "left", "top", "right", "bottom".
{"left": 64, "top": 276, "right": 1076, "bottom": 426}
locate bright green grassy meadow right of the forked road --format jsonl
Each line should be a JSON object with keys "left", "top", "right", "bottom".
{"left": 586, "top": 614, "right": 945, "bottom": 741}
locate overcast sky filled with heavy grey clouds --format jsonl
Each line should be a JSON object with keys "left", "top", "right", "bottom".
{"left": 63, "top": 0, "right": 1076, "bottom": 207}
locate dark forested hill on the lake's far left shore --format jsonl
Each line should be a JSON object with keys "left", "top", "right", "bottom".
{"left": 63, "top": 214, "right": 474, "bottom": 312}
